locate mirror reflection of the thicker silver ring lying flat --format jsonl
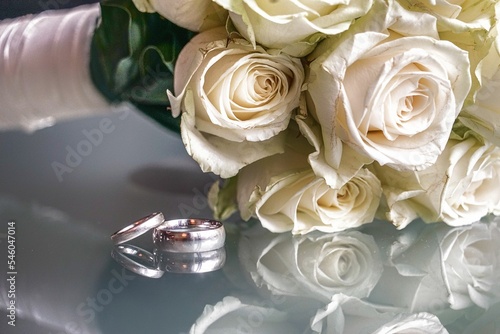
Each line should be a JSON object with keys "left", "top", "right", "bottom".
{"left": 155, "top": 247, "right": 226, "bottom": 274}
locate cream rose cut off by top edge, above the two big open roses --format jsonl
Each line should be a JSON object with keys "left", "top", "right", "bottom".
{"left": 214, "top": 0, "right": 373, "bottom": 56}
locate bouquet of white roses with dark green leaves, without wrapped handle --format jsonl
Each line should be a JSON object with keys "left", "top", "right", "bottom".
{"left": 0, "top": 0, "right": 500, "bottom": 234}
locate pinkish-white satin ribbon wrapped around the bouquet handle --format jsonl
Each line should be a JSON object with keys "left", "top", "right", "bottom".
{"left": 0, "top": 4, "right": 110, "bottom": 132}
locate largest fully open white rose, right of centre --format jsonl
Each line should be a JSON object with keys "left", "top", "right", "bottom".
{"left": 308, "top": 1, "right": 471, "bottom": 170}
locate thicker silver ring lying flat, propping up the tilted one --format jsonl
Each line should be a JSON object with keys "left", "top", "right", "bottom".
{"left": 153, "top": 219, "right": 226, "bottom": 253}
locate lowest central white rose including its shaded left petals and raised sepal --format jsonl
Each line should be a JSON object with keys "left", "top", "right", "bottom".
{"left": 237, "top": 122, "right": 382, "bottom": 234}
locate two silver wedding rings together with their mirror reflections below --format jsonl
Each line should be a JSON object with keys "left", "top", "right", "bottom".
{"left": 111, "top": 212, "right": 226, "bottom": 278}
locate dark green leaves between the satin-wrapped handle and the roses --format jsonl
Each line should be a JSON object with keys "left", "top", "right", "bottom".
{"left": 90, "top": 0, "right": 194, "bottom": 131}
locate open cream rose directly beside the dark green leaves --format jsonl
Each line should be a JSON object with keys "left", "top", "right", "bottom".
{"left": 169, "top": 28, "right": 304, "bottom": 178}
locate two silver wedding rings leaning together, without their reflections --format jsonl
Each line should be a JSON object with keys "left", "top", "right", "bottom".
{"left": 111, "top": 212, "right": 226, "bottom": 253}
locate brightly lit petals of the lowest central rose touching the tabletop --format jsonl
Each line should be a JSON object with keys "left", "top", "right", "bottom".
{"left": 253, "top": 169, "right": 381, "bottom": 234}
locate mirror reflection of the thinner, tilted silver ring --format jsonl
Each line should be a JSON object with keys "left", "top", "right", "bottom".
{"left": 111, "top": 245, "right": 165, "bottom": 278}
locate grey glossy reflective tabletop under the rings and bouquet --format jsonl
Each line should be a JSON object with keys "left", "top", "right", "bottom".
{"left": 0, "top": 106, "right": 500, "bottom": 334}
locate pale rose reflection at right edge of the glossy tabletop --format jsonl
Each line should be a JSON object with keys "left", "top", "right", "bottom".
{"left": 369, "top": 218, "right": 500, "bottom": 315}
